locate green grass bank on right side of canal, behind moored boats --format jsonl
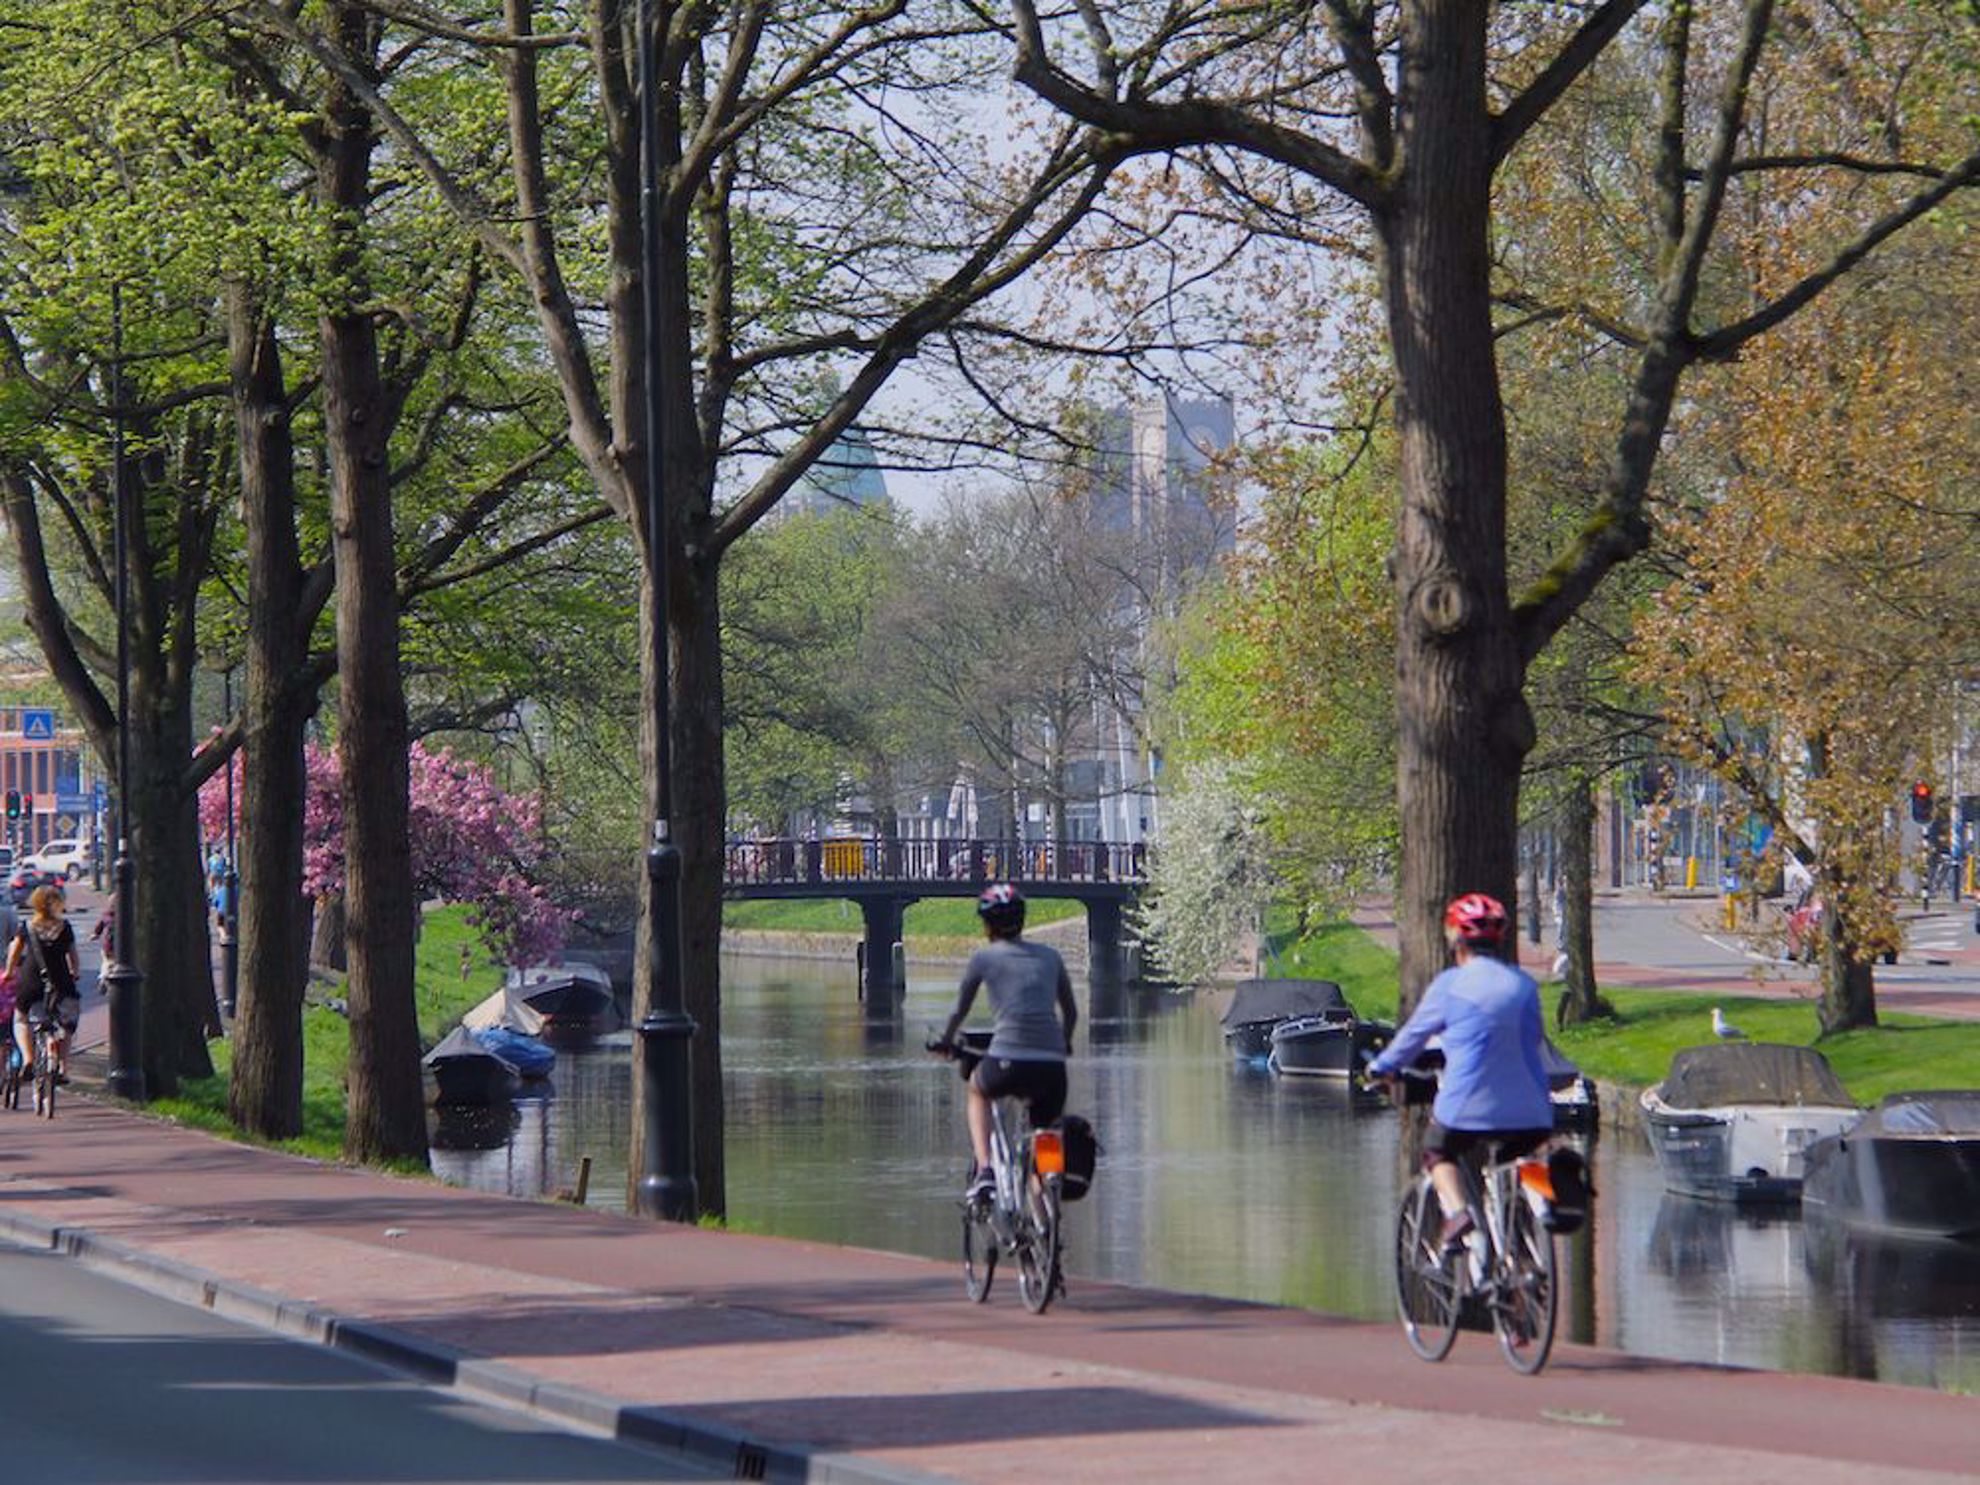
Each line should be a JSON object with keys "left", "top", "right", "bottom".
{"left": 1267, "top": 919, "right": 1980, "bottom": 1103}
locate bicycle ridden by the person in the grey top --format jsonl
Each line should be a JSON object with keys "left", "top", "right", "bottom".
{"left": 927, "top": 1032, "right": 1065, "bottom": 1315}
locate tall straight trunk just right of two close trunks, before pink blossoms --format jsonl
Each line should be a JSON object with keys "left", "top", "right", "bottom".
{"left": 319, "top": 4, "right": 426, "bottom": 1160}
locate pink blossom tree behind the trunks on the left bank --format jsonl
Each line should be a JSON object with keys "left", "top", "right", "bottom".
{"left": 200, "top": 743, "right": 572, "bottom": 964}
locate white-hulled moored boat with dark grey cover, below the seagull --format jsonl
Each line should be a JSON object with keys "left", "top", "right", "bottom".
{"left": 1641, "top": 1041, "right": 1863, "bottom": 1202}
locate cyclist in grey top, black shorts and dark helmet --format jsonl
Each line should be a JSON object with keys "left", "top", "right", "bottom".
{"left": 942, "top": 881, "right": 1079, "bottom": 1194}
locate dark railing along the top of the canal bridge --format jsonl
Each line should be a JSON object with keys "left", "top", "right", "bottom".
{"left": 723, "top": 836, "right": 1148, "bottom": 887}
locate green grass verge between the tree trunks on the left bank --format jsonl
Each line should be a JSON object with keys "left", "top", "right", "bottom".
{"left": 150, "top": 907, "right": 501, "bottom": 1160}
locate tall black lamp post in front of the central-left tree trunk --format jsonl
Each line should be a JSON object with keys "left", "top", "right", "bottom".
{"left": 634, "top": 0, "right": 697, "bottom": 1222}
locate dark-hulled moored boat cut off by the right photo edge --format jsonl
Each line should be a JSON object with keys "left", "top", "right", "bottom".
{"left": 1802, "top": 1089, "right": 1980, "bottom": 1241}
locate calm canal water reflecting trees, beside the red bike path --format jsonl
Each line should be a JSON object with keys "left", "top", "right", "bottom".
{"left": 434, "top": 956, "right": 1980, "bottom": 1394}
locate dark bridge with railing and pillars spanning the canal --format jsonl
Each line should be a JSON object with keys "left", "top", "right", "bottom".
{"left": 723, "top": 836, "right": 1146, "bottom": 1000}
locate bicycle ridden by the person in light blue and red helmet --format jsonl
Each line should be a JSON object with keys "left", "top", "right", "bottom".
{"left": 1396, "top": 1079, "right": 1560, "bottom": 1376}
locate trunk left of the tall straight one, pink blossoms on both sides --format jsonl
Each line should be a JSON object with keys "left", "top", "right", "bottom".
{"left": 228, "top": 283, "right": 315, "bottom": 1139}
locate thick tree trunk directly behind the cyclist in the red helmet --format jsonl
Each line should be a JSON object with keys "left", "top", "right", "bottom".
{"left": 1376, "top": 0, "right": 1533, "bottom": 1012}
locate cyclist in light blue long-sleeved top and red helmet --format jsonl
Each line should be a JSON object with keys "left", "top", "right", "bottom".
{"left": 1368, "top": 893, "right": 1554, "bottom": 1243}
